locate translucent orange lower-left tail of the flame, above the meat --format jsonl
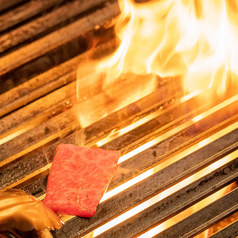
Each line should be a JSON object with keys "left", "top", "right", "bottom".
{"left": 76, "top": 61, "right": 156, "bottom": 128}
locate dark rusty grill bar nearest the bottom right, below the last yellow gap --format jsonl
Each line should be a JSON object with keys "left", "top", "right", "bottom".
{"left": 154, "top": 188, "right": 238, "bottom": 238}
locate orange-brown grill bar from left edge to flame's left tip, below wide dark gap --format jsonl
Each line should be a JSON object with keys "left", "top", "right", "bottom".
{"left": 0, "top": 41, "right": 115, "bottom": 118}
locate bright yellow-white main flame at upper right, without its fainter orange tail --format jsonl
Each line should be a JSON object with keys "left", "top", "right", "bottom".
{"left": 98, "top": 0, "right": 238, "bottom": 93}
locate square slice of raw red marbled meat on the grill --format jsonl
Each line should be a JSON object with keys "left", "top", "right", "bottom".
{"left": 44, "top": 144, "right": 120, "bottom": 217}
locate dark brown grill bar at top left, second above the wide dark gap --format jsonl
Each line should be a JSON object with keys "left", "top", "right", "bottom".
{"left": 0, "top": 0, "right": 111, "bottom": 53}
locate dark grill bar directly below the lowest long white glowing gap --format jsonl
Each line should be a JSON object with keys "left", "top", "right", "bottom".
{"left": 95, "top": 152, "right": 238, "bottom": 237}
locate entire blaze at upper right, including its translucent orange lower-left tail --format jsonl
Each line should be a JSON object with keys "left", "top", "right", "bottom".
{"left": 77, "top": 0, "right": 238, "bottom": 127}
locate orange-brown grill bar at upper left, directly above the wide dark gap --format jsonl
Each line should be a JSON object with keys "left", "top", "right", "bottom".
{"left": 0, "top": 0, "right": 119, "bottom": 75}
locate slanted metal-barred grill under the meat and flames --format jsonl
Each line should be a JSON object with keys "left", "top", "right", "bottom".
{"left": 0, "top": 0, "right": 238, "bottom": 238}
